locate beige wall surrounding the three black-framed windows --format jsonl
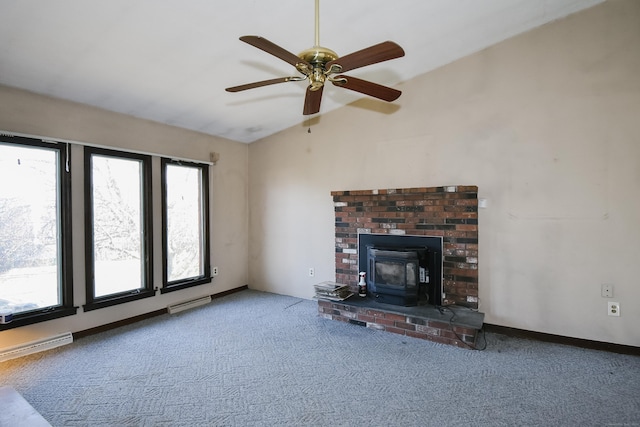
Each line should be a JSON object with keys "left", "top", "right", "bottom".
{"left": 0, "top": 86, "right": 248, "bottom": 349}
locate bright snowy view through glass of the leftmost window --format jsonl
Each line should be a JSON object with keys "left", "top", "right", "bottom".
{"left": 0, "top": 144, "right": 61, "bottom": 313}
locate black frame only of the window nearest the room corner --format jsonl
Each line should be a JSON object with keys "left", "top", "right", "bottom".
{"left": 160, "top": 157, "right": 212, "bottom": 294}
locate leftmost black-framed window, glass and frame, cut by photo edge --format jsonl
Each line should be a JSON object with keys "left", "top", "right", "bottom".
{"left": 0, "top": 136, "right": 76, "bottom": 330}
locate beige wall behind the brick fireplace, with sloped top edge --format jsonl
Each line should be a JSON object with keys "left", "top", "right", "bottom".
{"left": 249, "top": 0, "right": 640, "bottom": 346}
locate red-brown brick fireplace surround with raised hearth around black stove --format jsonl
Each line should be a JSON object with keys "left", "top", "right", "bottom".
{"left": 318, "top": 186, "right": 484, "bottom": 348}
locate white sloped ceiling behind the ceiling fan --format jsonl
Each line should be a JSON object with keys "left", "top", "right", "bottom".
{"left": 0, "top": 0, "right": 603, "bottom": 143}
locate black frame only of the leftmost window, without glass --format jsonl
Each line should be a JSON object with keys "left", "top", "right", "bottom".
{"left": 0, "top": 134, "right": 78, "bottom": 331}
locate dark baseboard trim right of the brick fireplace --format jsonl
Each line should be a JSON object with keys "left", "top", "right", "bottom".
{"left": 483, "top": 323, "right": 640, "bottom": 356}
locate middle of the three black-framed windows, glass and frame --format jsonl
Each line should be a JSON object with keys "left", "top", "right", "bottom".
{"left": 85, "top": 147, "right": 154, "bottom": 311}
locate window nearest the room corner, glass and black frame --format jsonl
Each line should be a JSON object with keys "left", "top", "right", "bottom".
{"left": 162, "top": 159, "right": 211, "bottom": 292}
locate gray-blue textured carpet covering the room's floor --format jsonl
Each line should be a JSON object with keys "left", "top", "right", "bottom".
{"left": 0, "top": 290, "right": 640, "bottom": 426}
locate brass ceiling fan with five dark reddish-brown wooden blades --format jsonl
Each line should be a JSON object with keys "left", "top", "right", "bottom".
{"left": 226, "top": 0, "right": 404, "bottom": 115}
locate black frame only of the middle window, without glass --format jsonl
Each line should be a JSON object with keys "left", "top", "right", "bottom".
{"left": 83, "top": 146, "right": 156, "bottom": 312}
